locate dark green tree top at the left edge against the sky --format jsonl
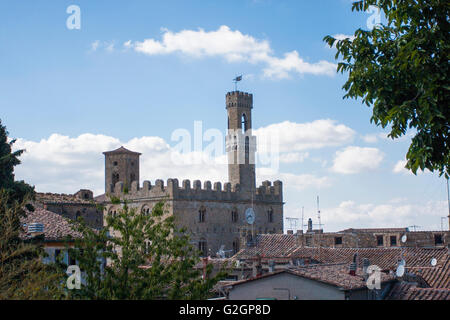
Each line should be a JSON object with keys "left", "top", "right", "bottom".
{"left": 0, "top": 120, "right": 34, "bottom": 202}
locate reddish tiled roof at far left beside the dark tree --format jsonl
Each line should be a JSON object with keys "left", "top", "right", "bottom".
{"left": 21, "top": 208, "right": 81, "bottom": 240}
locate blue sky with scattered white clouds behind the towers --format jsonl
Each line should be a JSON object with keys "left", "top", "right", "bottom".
{"left": 0, "top": 0, "right": 448, "bottom": 231}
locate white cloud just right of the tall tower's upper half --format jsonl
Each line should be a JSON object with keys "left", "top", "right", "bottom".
{"left": 254, "top": 119, "right": 355, "bottom": 152}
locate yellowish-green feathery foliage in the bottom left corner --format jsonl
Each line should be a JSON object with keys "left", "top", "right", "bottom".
{"left": 0, "top": 189, "right": 64, "bottom": 300}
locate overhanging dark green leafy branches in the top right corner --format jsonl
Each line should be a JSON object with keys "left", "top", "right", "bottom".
{"left": 324, "top": 0, "right": 450, "bottom": 178}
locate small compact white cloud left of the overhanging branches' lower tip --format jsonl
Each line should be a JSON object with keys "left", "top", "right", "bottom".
{"left": 331, "top": 146, "right": 384, "bottom": 174}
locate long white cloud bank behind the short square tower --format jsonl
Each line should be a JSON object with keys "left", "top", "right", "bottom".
{"left": 14, "top": 134, "right": 227, "bottom": 194}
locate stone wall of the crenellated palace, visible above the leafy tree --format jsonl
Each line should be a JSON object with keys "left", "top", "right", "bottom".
{"left": 105, "top": 179, "right": 283, "bottom": 256}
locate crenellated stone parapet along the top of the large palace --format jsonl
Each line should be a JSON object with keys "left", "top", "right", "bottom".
{"left": 110, "top": 179, "right": 283, "bottom": 202}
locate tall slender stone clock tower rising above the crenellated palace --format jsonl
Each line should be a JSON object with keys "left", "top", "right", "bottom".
{"left": 226, "top": 91, "right": 256, "bottom": 192}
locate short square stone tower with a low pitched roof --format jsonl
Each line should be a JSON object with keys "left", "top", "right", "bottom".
{"left": 103, "top": 147, "right": 141, "bottom": 193}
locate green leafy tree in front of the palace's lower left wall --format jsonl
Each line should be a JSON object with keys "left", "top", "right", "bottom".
{"left": 70, "top": 199, "right": 229, "bottom": 300}
